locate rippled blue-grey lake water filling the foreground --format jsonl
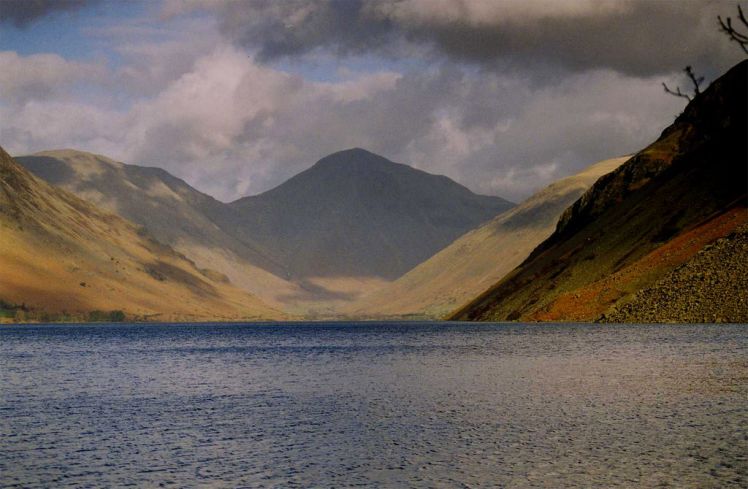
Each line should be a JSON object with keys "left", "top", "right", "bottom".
{"left": 0, "top": 323, "right": 748, "bottom": 488}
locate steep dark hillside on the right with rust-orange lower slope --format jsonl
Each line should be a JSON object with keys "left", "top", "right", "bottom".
{"left": 453, "top": 61, "right": 748, "bottom": 321}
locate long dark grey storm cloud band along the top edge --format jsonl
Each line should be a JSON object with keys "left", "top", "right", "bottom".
{"left": 188, "top": 0, "right": 740, "bottom": 76}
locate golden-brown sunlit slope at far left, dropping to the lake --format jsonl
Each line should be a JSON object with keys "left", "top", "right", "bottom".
{"left": 0, "top": 148, "right": 283, "bottom": 320}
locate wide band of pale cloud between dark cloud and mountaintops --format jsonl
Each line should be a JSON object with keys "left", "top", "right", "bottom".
{"left": 0, "top": 33, "right": 682, "bottom": 200}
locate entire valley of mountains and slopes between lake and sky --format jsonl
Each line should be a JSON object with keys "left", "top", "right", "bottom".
{"left": 0, "top": 61, "right": 748, "bottom": 322}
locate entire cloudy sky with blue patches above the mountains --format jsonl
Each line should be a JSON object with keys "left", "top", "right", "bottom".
{"left": 0, "top": 0, "right": 741, "bottom": 201}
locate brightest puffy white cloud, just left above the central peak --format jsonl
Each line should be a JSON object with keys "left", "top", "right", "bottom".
{"left": 112, "top": 45, "right": 398, "bottom": 199}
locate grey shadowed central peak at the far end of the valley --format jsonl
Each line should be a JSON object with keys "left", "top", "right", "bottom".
{"left": 222, "top": 149, "right": 512, "bottom": 279}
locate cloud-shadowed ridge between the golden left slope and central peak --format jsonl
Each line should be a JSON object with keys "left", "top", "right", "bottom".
{"left": 16, "top": 149, "right": 302, "bottom": 307}
